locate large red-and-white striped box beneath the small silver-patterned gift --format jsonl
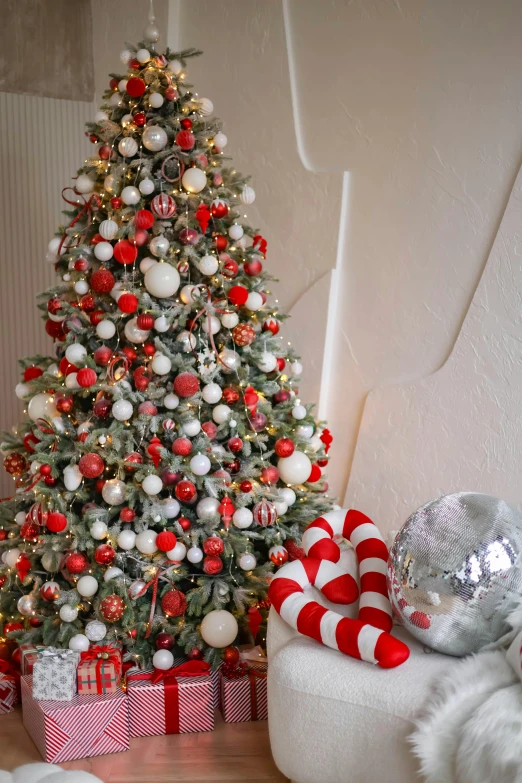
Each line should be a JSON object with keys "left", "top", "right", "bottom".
{"left": 22, "top": 677, "right": 129, "bottom": 764}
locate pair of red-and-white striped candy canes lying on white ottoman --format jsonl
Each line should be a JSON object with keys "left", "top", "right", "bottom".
{"left": 268, "top": 510, "right": 410, "bottom": 669}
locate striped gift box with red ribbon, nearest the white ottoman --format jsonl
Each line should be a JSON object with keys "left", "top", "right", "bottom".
{"left": 221, "top": 662, "right": 268, "bottom": 723}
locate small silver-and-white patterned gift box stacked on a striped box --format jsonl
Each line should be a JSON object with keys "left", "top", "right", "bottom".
{"left": 33, "top": 647, "right": 80, "bottom": 701}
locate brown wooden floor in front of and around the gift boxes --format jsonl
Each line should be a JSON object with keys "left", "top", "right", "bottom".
{"left": 0, "top": 707, "right": 287, "bottom": 783}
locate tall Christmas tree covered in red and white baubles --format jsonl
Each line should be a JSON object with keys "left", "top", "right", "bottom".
{"left": 0, "top": 18, "right": 331, "bottom": 668}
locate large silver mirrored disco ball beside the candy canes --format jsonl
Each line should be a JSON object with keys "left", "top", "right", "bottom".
{"left": 388, "top": 492, "right": 522, "bottom": 655}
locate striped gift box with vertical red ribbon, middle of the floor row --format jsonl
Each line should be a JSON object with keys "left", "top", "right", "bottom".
{"left": 127, "top": 661, "right": 214, "bottom": 737}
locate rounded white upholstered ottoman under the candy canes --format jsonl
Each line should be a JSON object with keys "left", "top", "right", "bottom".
{"left": 268, "top": 608, "right": 459, "bottom": 783}
